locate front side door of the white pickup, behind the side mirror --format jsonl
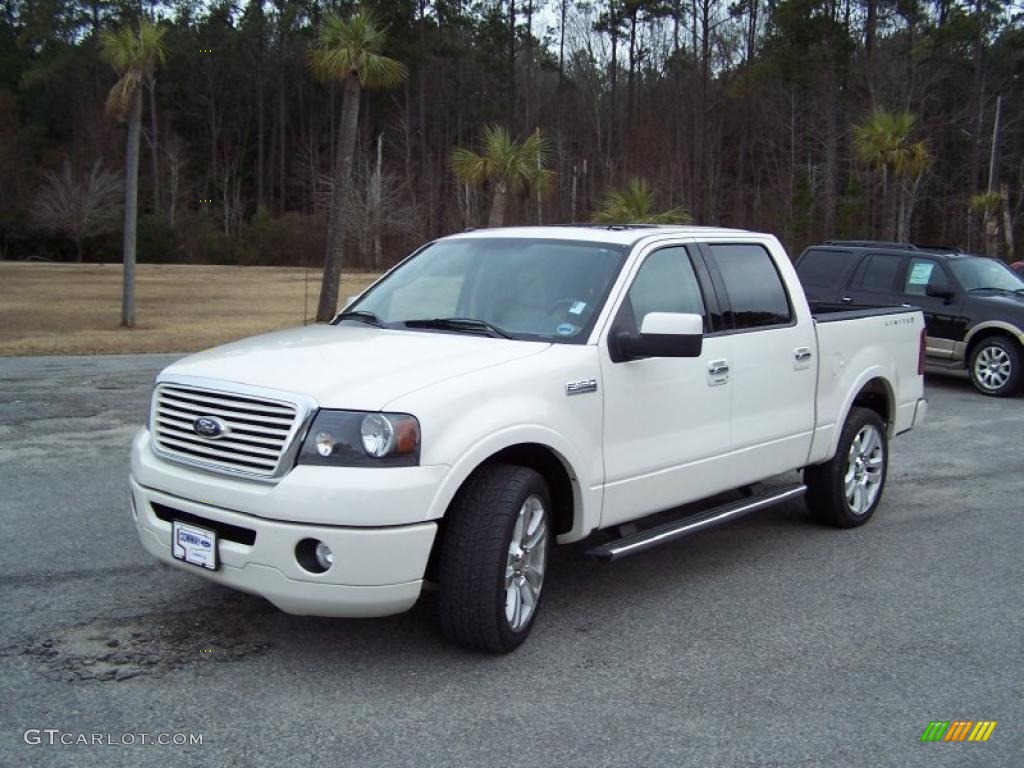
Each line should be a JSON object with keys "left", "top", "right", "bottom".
{"left": 600, "top": 246, "right": 732, "bottom": 526}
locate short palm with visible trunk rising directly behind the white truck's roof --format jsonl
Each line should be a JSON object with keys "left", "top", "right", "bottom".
{"left": 452, "top": 125, "right": 555, "bottom": 226}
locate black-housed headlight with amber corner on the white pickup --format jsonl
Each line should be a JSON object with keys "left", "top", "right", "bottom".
{"left": 296, "top": 411, "right": 420, "bottom": 467}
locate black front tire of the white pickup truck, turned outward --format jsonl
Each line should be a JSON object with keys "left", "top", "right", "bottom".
{"left": 438, "top": 464, "right": 551, "bottom": 653}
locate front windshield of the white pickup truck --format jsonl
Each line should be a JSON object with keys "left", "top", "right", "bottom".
{"left": 342, "top": 238, "right": 626, "bottom": 344}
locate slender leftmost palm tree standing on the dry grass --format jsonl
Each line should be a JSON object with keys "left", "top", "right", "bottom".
{"left": 99, "top": 18, "right": 166, "bottom": 328}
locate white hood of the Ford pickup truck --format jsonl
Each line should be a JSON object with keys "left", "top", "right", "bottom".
{"left": 161, "top": 325, "right": 551, "bottom": 411}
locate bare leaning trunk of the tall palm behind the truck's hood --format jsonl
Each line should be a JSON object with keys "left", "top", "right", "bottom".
{"left": 316, "top": 75, "right": 362, "bottom": 323}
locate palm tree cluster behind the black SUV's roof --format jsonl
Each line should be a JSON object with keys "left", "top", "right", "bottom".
{"left": 853, "top": 109, "right": 933, "bottom": 240}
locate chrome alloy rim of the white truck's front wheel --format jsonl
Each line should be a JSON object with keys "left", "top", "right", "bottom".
{"left": 505, "top": 496, "right": 548, "bottom": 632}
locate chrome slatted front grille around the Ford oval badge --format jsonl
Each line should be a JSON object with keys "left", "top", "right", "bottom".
{"left": 152, "top": 382, "right": 303, "bottom": 477}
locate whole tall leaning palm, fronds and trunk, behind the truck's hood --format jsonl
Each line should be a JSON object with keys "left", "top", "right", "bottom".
{"left": 309, "top": 9, "right": 408, "bottom": 321}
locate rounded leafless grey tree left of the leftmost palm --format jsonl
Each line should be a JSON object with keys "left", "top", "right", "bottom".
{"left": 30, "top": 160, "right": 122, "bottom": 262}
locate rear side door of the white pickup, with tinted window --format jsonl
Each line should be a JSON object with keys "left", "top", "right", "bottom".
{"left": 702, "top": 242, "right": 817, "bottom": 485}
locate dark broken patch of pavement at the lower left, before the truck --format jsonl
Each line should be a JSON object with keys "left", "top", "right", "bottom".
{"left": 8, "top": 603, "right": 274, "bottom": 682}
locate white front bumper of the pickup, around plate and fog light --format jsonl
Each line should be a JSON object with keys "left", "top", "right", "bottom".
{"left": 131, "top": 476, "right": 437, "bottom": 616}
